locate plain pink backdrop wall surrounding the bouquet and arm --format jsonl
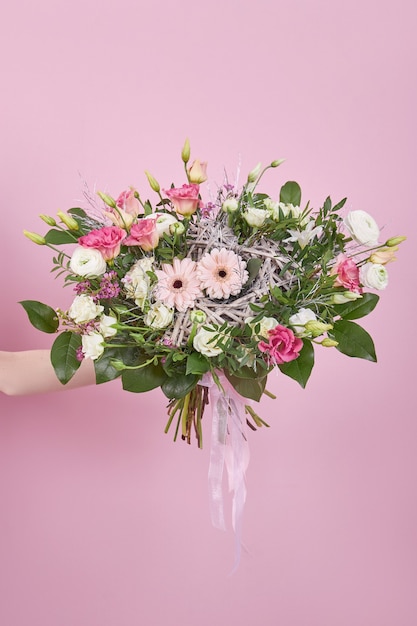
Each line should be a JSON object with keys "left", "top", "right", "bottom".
{"left": 0, "top": 0, "right": 417, "bottom": 626}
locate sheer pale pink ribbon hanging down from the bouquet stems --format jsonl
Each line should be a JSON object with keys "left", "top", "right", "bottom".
{"left": 199, "top": 373, "right": 249, "bottom": 572}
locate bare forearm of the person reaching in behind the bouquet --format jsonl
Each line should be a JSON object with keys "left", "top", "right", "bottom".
{"left": 0, "top": 350, "right": 95, "bottom": 396}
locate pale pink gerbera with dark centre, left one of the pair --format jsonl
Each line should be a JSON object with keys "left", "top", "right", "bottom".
{"left": 155, "top": 259, "right": 202, "bottom": 312}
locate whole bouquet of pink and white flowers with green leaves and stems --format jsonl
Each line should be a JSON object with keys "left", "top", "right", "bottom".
{"left": 22, "top": 140, "right": 405, "bottom": 446}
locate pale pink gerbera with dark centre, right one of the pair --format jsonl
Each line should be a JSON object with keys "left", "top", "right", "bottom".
{"left": 197, "top": 248, "right": 249, "bottom": 298}
